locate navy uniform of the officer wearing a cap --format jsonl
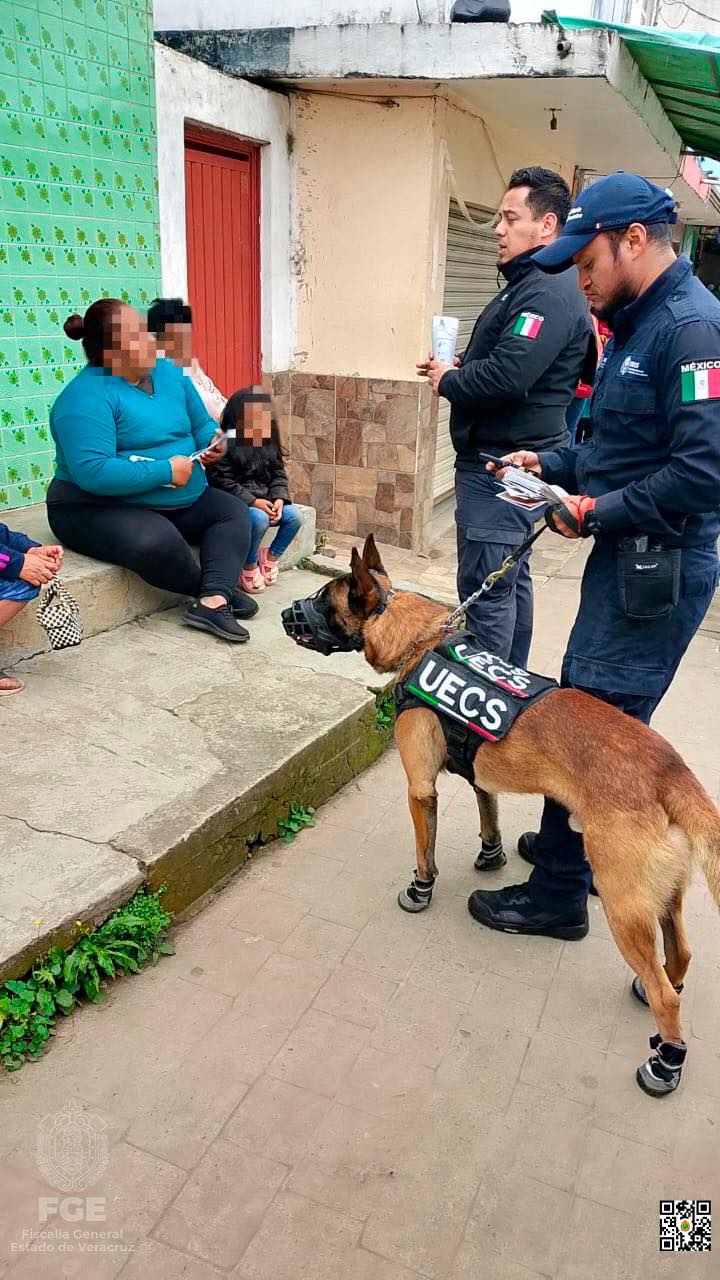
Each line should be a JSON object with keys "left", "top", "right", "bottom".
{"left": 530, "top": 257, "right": 720, "bottom": 914}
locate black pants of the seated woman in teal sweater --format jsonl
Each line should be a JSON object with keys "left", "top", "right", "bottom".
{"left": 47, "top": 480, "right": 250, "bottom": 600}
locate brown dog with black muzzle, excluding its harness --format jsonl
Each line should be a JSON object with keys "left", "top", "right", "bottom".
{"left": 283, "top": 535, "right": 720, "bottom": 1094}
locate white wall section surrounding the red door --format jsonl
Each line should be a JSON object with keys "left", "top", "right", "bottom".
{"left": 155, "top": 44, "right": 295, "bottom": 372}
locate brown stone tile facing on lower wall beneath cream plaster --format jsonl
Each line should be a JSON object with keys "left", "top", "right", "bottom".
{"left": 273, "top": 372, "right": 437, "bottom": 550}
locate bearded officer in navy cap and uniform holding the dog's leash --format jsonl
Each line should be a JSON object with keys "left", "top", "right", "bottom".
{"left": 469, "top": 173, "right": 720, "bottom": 940}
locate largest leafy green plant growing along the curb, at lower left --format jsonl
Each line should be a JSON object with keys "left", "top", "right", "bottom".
{"left": 0, "top": 890, "right": 173, "bottom": 1071}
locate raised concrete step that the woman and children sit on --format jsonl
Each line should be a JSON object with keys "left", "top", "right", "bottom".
{"left": 0, "top": 504, "right": 315, "bottom": 667}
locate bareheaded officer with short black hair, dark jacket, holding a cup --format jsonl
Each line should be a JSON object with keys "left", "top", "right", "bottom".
{"left": 418, "top": 166, "right": 596, "bottom": 667}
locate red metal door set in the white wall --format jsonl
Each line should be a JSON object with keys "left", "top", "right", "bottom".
{"left": 184, "top": 129, "right": 261, "bottom": 396}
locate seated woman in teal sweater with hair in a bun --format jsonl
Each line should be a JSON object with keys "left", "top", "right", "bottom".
{"left": 47, "top": 298, "right": 258, "bottom": 643}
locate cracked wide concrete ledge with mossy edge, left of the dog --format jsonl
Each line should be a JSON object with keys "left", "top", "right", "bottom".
{"left": 0, "top": 570, "right": 388, "bottom": 980}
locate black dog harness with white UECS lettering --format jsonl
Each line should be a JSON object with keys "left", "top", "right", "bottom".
{"left": 395, "top": 631, "right": 559, "bottom": 783}
